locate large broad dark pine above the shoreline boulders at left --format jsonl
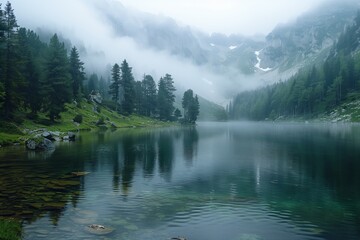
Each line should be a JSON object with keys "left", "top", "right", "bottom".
{"left": 44, "top": 34, "right": 72, "bottom": 121}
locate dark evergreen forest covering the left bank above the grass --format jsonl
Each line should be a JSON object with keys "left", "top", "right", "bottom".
{"left": 0, "top": 2, "right": 199, "bottom": 126}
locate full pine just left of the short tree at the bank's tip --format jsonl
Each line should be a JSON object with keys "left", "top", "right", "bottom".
{"left": 158, "top": 74, "right": 176, "bottom": 120}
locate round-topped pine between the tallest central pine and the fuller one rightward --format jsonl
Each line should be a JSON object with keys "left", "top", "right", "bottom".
{"left": 141, "top": 75, "right": 157, "bottom": 117}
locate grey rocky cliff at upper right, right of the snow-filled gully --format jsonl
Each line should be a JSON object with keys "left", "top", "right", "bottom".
{"left": 260, "top": 1, "right": 360, "bottom": 72}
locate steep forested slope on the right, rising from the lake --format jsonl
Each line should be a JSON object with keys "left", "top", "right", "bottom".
{"left": 229, "top": 11, "right": 360, "bottom": 121}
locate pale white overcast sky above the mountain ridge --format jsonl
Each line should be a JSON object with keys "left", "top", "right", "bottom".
{"left": 118, "top": 0, "right": 326, "bottom": 35}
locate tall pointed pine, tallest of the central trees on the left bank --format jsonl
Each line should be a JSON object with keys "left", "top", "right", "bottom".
{"left": 121, "top": 60, "right": 135, "bottom": 114}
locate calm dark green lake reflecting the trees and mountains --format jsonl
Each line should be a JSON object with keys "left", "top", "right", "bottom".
{"left": 0, "top": 123, "right": 360, "bottom": 240}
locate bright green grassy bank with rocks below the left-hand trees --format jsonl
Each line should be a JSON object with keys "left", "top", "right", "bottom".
{"left": 0, "top": 101, "right": 175, "bottom": 147}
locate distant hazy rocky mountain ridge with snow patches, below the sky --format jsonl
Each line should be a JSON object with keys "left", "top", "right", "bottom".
{"left": 92, "top": 0, "right": 360, "bottom": 80}
